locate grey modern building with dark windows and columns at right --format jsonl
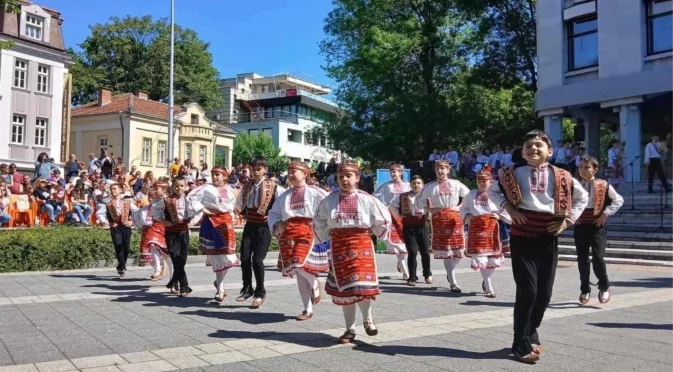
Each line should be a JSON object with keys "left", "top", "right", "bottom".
{"left": 536, "top": 0, "right": 673, "bottom": 179}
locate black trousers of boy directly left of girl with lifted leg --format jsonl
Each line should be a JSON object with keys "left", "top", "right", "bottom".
{"left": 241, "top": 222, "right": 271, "bottom": 297}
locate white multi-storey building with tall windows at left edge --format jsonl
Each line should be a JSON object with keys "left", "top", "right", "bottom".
{"left": 0, "top": 1, "right": 72, "bottom": 174}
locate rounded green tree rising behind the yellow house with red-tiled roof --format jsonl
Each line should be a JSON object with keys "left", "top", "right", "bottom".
{"left": 69, "top": 16, "right": 223, "bottom": 108}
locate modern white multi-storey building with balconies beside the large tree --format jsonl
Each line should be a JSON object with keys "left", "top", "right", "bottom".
{"left": 208, "top": 73, "right": 337, "bottom": 162}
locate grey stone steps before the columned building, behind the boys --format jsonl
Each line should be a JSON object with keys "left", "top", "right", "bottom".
{"left": 559, "top": 181, "right": 673, "bottom": 267}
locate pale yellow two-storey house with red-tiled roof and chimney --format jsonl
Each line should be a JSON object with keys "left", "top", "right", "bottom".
{"left": 70, "top": 88, "right": 235, "bottom": 176}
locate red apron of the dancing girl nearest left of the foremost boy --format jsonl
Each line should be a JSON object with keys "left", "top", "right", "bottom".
{"left": 465, "top": 215, "right": 502, "bottom": 257}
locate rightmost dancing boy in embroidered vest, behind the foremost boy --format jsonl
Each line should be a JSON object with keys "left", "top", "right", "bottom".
{"left": 573, "top": 155, "right": 624, "bottom": 305}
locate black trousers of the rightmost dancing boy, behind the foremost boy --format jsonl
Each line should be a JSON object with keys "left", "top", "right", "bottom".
{"left": 573, "top": 223, "right": 610, "bottom": 293}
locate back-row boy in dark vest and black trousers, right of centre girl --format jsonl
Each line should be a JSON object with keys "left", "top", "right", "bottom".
{"left": 388, "top": 176, "right": 432, "bottom": 287}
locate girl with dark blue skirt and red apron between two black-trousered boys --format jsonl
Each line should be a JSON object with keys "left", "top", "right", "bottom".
{"left": 187, "top": 166, "right": 239, "bottom": 302}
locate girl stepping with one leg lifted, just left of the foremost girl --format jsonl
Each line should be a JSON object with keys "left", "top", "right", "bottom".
{"left": 268, "top": 162, "right": 329, "bottom": 321}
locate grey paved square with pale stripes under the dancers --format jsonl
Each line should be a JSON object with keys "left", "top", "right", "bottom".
{"left": 0, "top": 255, "right": 673, "bottom": 372}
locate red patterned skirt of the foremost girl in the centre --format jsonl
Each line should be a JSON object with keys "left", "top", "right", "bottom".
{"left": 325, "top": 228, "right": 381, "bottom": 306}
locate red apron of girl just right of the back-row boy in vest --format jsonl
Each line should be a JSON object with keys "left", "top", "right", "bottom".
{"left": 431, "top": 209, "right": 465, "bottom": 259}
